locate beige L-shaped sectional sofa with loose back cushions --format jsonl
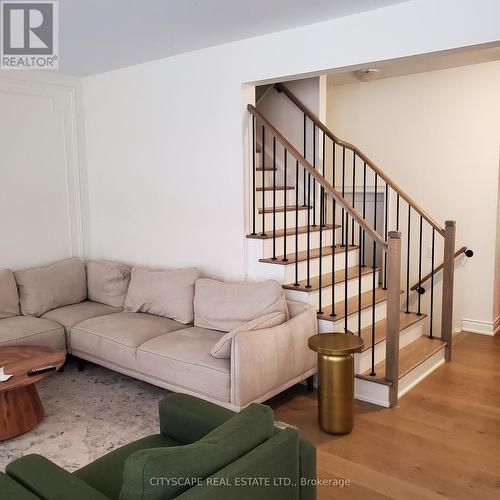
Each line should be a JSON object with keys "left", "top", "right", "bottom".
{"left": 0, "top": 258, "right": 317, "bottom": 409}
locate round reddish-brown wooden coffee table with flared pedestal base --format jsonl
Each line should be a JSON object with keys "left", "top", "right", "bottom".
{"left": 0, "top": 346, "right": 66, "bottom": 441}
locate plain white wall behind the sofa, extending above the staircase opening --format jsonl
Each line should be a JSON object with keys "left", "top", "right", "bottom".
{"left": 83, "top": 0, "right": 500, "bottom": 279}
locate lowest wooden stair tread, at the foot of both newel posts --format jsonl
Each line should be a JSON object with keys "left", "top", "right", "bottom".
{"left": 356, "top": 336, "right": 446, "bottom": 385}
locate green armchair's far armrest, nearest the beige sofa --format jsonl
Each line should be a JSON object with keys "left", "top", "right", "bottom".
{"left": 160, "top": 393, "right": 235, "bottom": 444}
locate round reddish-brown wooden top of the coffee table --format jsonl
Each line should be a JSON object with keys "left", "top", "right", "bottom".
{"left": 0, "top": 345, "right": 66, "bottom": 392}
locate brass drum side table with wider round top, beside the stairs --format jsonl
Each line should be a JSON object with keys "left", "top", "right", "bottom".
{"left": 309, "top": 333, "right": 363, "bottom": 434}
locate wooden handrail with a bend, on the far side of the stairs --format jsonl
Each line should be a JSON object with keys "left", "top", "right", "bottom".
{"left": 275, "top": 83, "right": 445, "bottom": 237}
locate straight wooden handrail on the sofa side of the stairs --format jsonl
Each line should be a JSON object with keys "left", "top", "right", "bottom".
{"left": 247, "top": 104, "right": 388, "bottom": 250}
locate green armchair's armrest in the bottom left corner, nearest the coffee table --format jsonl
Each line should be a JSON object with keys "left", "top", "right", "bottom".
{"left": 6, "top": 455, "right": 109, "bottom": 500}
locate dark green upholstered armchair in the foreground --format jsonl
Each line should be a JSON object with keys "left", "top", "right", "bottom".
{"left": 4, "top": 394, "right": 316, "bottom": 500}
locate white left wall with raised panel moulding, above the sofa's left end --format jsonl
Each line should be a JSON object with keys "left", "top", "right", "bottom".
{"left": 0, "top": 71, "right": 83, "bottom": 269}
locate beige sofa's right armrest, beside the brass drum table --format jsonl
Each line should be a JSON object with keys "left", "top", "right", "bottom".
{"left": 231, "top": 306, "right": 318, "bottom": 407}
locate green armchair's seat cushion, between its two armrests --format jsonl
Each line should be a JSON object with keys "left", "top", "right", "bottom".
{"left": 74, "top": 434, "right": 181, "bottom": 500}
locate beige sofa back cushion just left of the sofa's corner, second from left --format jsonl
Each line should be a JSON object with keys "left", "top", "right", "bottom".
{"left": 14, "top": 258, "right": 87, "bottom": 316}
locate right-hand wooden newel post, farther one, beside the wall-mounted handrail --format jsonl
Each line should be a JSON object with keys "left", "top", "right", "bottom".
{"left": 441, "top": 220, "right": 457, "bottom": 361}
